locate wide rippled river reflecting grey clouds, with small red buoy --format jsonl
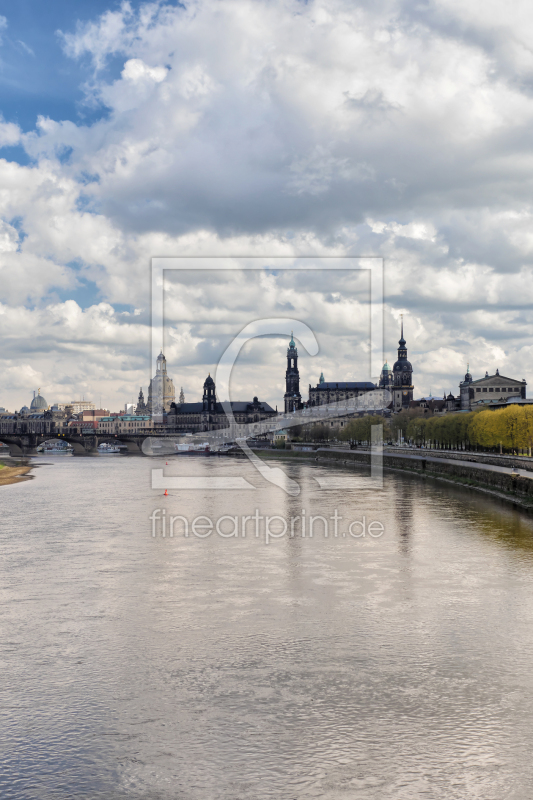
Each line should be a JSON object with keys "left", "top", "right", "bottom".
{"left": 0, "top": 456, "right": 533, "bottom": 800}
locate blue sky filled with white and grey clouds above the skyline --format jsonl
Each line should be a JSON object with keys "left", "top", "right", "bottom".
{"left": 0, "top": 0, "right": 533, "bottom": 410}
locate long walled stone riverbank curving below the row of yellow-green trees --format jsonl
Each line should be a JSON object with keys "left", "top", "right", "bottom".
{"left": 250, "top": 448, "right": 533, "bottom": 513}
